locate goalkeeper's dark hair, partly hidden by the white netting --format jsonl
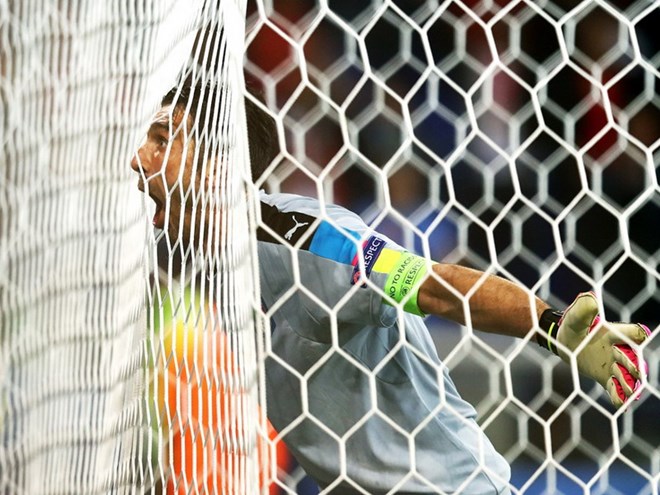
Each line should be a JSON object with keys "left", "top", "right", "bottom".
{"left": 161, "top": 81, "right": 279, "bottom": 181}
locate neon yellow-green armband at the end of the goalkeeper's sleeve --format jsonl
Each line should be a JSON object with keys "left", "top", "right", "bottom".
{"left": 385, "top": 251, "right": 428, "bottom": 316}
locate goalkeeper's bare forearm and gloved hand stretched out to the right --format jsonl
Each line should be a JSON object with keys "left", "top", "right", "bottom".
{"left": 417, "top": 263, "right": 650, "bottom": 407}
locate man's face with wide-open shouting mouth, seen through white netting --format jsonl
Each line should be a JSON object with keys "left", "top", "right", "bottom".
{"left": 131, "top": 105, "right": 199, "bottom": 242}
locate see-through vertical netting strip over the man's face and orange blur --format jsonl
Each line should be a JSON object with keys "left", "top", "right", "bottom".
{"left": 139, "top": 2, "right": 269, "bottom": 494}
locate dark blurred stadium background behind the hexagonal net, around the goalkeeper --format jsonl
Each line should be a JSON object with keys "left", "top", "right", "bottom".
{"left": 245, "top": 0, "right": 660, "bottom": 494}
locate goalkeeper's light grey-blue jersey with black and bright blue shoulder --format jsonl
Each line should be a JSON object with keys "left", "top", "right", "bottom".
{"left": 258, "top": 193, "right": 510, "bottom": 495}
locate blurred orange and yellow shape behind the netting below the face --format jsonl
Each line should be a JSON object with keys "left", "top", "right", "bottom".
{"left": 157, "top": 321, "right": 291, "bottom": 495}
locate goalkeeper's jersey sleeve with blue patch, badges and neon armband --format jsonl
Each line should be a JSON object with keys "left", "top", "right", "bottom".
{"left": 260, "top": 194, "right": 438, "bottom": 334}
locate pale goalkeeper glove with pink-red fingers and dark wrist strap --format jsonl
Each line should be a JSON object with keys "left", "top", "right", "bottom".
{"left": 538, "top": 292, "right": 651, "bottom": 408}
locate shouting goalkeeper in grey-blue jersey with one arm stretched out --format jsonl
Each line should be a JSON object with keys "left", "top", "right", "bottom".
{"left": 131, "top": 83, "right": 649, "bottom": 494}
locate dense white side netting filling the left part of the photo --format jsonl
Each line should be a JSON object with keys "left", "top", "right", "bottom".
{"left": 0, "top": 0, "right": 266, "bottom": 494}
